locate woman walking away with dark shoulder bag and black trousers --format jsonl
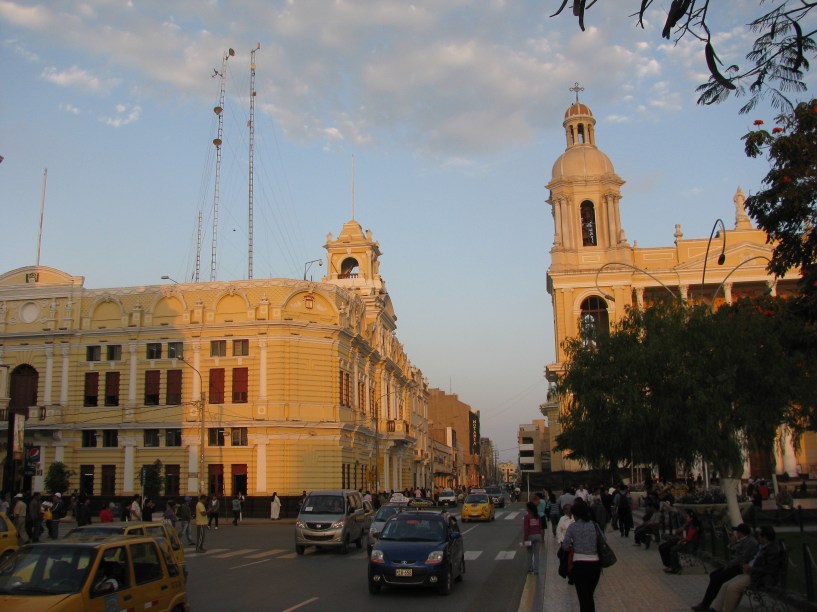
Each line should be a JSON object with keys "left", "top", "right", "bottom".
{"left": 562, "top": 499, "right": 604, "bottom": 612}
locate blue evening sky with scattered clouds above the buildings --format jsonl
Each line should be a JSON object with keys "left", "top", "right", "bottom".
{"left": 0, "top": 0, "right": 813, "bottom": 462}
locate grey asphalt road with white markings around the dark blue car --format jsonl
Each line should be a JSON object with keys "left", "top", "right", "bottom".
{"left": 187, "top": 504, "right": 526, "bottom": 612}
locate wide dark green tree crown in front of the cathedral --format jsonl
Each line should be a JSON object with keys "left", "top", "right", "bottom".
{"left": 556, "top": 296, "right": 817, "bottom": 476}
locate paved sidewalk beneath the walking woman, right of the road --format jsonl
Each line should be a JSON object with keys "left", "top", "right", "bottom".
{"left": 520, "top": 530, "right": 751, "bottom": 612}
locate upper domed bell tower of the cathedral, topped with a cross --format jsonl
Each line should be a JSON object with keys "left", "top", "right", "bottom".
{"left": 547, "top": 84, "right": 631, "bottom": 272}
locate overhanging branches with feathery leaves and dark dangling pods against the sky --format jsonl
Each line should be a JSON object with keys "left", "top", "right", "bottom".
{"left": 551, "top": 0, "right": 817, "bottom": 113}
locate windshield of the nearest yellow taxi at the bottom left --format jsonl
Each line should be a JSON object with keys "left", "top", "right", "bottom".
{"left": 0, "top": 544, "right": 97, "bottom": 595}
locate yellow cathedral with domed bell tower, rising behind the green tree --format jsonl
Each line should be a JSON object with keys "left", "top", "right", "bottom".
{"left": 542, "top": 99, "right": 804, "bottom": 476}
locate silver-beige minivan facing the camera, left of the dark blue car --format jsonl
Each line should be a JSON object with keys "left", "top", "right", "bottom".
{"left": 295, "top": 489, "right": 366, "bottom": 555}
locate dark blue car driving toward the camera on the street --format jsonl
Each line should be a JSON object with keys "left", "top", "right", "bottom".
{"left": 369, "top": 510, "right": 465, "bottom": 595}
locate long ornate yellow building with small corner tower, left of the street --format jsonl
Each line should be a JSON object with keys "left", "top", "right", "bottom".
{"left": 0, "top": 220, "right": 432, "bottom": 496}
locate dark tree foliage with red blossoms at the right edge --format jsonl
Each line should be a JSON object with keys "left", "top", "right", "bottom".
{"left": 743, "top": 99, "right": 817, "bottom": 302}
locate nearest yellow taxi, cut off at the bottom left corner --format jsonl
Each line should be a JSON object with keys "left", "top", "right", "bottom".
{"left": 0, "top": 536, "right": 190, "bottom": 612}
